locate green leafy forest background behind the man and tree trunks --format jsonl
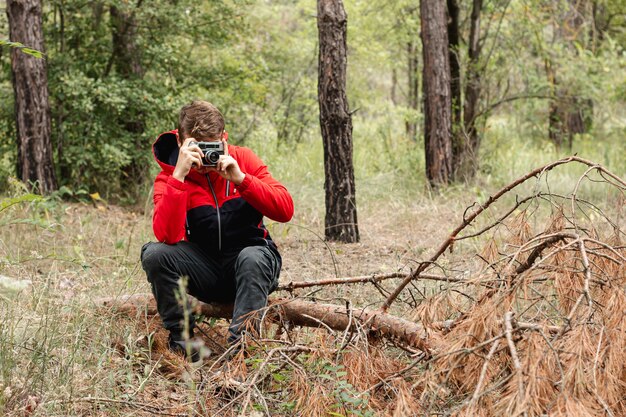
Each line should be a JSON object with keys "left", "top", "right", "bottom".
{"left": 0, "top": 0, "right": 626, "bottom": 204}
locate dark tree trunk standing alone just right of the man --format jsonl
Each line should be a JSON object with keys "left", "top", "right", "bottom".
{"left": 317, "top": 0, "right": 359, "bottom": 242}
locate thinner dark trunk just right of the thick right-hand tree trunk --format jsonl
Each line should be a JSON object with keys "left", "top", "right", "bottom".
{"left": 456, "top": 0, "right": 483, "bottom": 180}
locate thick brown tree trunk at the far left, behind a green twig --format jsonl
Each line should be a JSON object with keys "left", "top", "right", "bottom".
{"left": 6, "top": 0, "right": 57, "bottom": 194}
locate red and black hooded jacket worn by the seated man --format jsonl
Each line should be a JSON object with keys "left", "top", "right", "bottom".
{"left": 152, "top": 130, "right": 293, "bottom": 254}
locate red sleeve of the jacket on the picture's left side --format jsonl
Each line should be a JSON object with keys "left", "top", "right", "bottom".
{"left": 152, "top": 172, "right": 187, "bottom": 245}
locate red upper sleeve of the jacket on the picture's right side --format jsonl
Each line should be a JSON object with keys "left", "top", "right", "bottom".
{"left": 237, "top": 150, "right": 293, "bottom": 222}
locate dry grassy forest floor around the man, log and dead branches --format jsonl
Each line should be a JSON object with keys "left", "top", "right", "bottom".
{"left": 0, "top": 156, "right": 626, "bottom": 416}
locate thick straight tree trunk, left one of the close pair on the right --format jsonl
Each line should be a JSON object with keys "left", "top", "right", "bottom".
{"left": 420, "top": 0, "right": 452, "bottom": 187}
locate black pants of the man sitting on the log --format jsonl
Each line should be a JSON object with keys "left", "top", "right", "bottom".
{"left": 141, "top": 241, "right": 282, "bottom": 343}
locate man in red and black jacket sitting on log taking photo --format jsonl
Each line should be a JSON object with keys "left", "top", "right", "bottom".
{"left": 141, "top": 101, "right": 293, "bottom": 360}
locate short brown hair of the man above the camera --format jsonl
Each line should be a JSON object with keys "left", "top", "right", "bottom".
{"left": 178, "top": 100, "right": 224, "bottom": 142}
